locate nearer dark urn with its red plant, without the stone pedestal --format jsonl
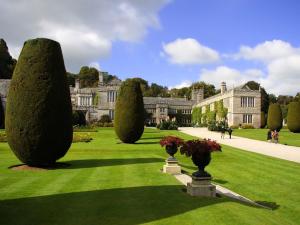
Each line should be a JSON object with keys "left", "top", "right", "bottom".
{"left": 180, "top": 139, "right": 221, "bottom": 177}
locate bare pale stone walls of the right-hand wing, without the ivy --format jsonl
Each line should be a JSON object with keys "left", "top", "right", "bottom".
{"left": 194, "top": 82, "right": 261, "bottom": 128}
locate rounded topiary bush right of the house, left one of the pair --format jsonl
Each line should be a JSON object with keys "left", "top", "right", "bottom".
{"left": 267, "top": 103, "right": 282, "bottom": 131}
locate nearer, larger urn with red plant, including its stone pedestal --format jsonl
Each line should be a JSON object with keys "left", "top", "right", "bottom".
{"left": 180, "top": 140, "right": 221, "bottom": 197}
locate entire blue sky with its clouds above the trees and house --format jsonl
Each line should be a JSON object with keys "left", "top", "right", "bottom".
{"left": 0, "top": 0, "right": 300, "bottom": 95}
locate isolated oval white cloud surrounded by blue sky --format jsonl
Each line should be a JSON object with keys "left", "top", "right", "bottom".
{"left": 163, "top": 38, "right": 220, "bottom": 65}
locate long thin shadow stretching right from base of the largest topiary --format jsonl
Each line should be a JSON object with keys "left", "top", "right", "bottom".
{"left": 63, "top": 158, "right": 164, "bottom": 169}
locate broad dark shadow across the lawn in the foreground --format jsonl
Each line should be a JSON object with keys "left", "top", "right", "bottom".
{"left": 0, "top": 185, "right": 253, "bottom": 225}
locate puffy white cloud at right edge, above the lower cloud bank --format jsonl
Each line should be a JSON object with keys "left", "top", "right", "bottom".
{"left": 234, "top": 40, "right": 300, "bottom": 63}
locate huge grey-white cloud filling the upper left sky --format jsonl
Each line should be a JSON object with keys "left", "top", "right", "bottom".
{"left": 0, "top": 0, "right": 169, "bottom": 72}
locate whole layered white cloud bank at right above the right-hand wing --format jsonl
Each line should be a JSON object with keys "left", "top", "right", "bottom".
{"left": 207, "top": 40, "right": 300, "bottom": 95}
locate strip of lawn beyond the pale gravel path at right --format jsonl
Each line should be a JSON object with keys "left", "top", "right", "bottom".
{"left": 232, "top": 129, "right": 300, "bottom": 147}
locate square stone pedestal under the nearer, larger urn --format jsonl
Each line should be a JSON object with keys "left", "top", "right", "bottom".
{"left": 187, "top": 176, "right": 216, "bottom": 197}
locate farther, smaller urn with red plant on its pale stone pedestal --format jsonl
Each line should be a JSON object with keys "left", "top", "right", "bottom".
{"left": 159, "top": 136, "right": 183, "bottom": 174}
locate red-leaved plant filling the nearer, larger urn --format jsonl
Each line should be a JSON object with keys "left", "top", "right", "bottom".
{"left": 180, "top": 139, "right": 221, "bottom": 157}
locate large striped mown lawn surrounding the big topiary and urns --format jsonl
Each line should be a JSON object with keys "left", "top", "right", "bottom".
{"left": 0, "top": 128, "right": 300, "bottom": 225}
